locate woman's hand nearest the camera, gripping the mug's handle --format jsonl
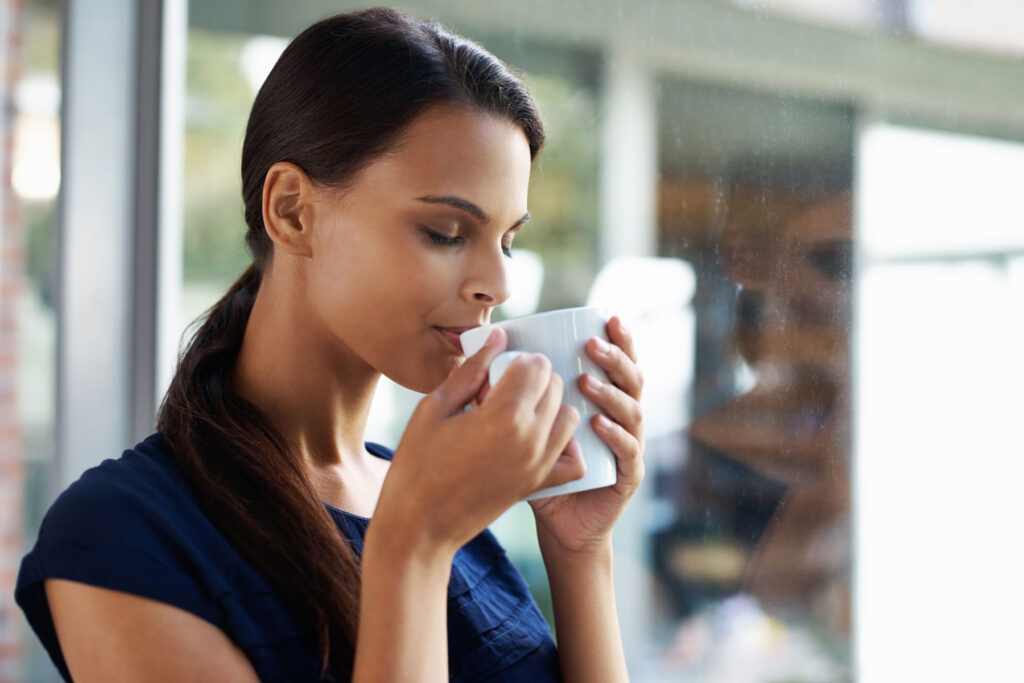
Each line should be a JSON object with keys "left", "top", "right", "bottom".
{"left": 374, "top": 330, "right": 585, "bottom": 554}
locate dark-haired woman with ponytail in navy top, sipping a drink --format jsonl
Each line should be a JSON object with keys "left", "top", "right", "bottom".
{"left": 17, "top": 10, "right": 643, "bottom": 681}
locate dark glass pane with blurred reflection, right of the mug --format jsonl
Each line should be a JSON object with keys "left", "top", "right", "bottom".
{"left": 648, "top": 79, "right": 854, "bottom": 681}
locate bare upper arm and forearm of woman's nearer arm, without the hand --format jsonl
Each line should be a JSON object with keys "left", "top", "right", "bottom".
{"left": 46, "top": 536, "right": 455, "bottom": 683}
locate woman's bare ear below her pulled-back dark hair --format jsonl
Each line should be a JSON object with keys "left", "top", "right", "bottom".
{"left": 263, "top": 162, "right": 316, "bottom": 258}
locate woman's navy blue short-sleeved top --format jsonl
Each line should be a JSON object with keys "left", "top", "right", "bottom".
{"left": 14, "top": 434, "right": 561, "bottom": 683}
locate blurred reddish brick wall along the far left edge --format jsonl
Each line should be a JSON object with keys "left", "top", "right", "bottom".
{"left": 0, "top": 0, "right": 26, "bottom": 683}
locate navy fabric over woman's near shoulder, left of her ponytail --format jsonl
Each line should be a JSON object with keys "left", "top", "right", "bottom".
{"left": 15, "top": 434, "right": 339, "bottom": 680}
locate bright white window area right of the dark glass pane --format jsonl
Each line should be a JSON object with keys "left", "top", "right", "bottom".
{"left": 854, "top": 126, "right": 1024, "bottom": 683}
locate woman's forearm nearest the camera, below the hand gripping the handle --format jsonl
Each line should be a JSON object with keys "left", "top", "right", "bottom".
{"left": 352, "top": 520, "right": 454, "bottom": 683}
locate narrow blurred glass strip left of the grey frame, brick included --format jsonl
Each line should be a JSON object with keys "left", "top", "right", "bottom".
{"left": 0, "top": 0, "right": 60, "bottom": 681}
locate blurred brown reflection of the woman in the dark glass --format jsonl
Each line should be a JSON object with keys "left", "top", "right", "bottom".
{"left": 690, "top": 193, "right": 852, "bottom": 635}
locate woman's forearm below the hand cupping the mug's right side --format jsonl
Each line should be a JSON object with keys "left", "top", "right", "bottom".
{"left": 538, "top": 531, "right": 629, "bottom": 683}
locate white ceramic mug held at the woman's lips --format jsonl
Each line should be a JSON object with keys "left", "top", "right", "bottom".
{"left": 460, "top": 307, "right": 617, "bottom": 501}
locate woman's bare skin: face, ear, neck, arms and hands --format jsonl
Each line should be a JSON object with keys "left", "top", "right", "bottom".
{"left": 47, "top": 106, "right": 643, "bottom": 682}
